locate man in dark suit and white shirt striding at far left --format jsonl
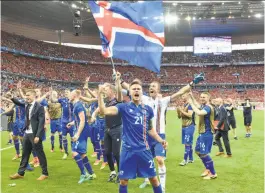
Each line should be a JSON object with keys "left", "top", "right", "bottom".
{"left": 10, "top": 90, "right": 48, "bottom": 180}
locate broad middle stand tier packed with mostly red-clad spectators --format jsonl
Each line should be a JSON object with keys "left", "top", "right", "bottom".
{"left": 1, "top": 53, "right": 264, "bottom": 84}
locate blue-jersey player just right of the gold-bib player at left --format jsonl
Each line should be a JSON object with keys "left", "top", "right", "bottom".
{"left": 51, "top": 89, "right": 75, "bottom": 160}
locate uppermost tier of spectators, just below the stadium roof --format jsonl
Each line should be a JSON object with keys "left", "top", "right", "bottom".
{"left": 1, "top": 31, "right": 264, "bottom": 64}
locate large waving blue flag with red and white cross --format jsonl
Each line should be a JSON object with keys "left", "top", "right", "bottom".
{"left": 88, "top": 0, "right": 165, "bottom": 73}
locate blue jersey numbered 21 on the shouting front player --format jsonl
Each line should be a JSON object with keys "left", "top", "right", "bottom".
{"left": 116, "top": 102, "right": 154, "bottom": 151}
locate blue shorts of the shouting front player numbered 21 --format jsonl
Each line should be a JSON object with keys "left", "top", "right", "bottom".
{"left": 119, "top": 150, "right": 156, "bottom": 179}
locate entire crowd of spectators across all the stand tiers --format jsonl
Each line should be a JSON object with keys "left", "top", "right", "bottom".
{"left": 1, "top": 31, "right": 264, "bottom": 101}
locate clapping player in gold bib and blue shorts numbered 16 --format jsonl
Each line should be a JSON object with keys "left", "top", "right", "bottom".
{"left": 188, "top": 92, "right": 217, "bottom": 180}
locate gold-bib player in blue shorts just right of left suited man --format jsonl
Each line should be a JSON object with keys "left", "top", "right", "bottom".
{"left": 48, "top": 91, "right": 63, "bottom": 152}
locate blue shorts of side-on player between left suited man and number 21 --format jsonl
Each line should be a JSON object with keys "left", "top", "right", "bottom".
{"left": 72, "top": 129, "right": 89, "bottom": 154}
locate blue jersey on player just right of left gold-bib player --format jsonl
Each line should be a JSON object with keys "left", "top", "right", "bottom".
{"left": 58, "top": 98, "right": 74, "bottom": 123}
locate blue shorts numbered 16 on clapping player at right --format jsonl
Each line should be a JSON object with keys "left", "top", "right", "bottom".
{"left": 195, "top": 131, "right": 213, "bottom": 154}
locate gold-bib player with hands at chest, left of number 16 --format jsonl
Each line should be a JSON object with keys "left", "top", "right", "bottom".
{"left": 177, "top": 94, "right": 195, "bottom": 166}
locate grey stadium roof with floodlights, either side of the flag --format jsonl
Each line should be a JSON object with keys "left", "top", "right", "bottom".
{"left": 1, "top": 1, "right": 264, "bottom": 46}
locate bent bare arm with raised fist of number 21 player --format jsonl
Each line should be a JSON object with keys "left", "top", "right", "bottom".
{"left": 98, "top": 85, "right": 119, "bottom": 115}
